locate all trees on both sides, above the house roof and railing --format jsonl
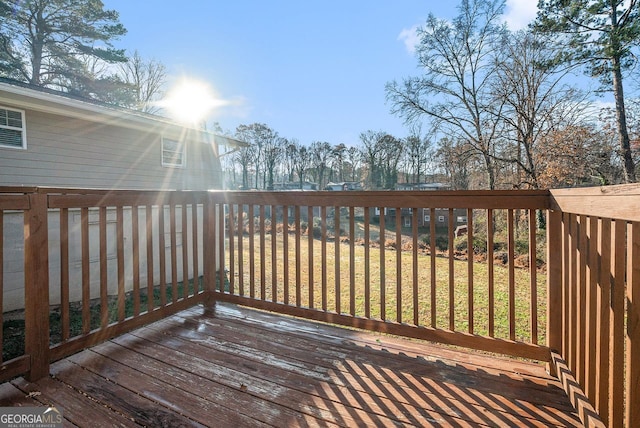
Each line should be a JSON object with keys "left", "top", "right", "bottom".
{"left": 0, "top": 0, "right": 640, "bottom": 189}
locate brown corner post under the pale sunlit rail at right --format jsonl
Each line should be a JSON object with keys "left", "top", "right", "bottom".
{"left": 547, "top": 210, "right": 563, "bottom": 375}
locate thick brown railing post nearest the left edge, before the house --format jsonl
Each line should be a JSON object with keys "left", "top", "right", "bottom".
{"left": 24, "top": 193, "right": 49, "bottom": 381}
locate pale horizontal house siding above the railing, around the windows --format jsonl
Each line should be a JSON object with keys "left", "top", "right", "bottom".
{"left": 0, "top": 105, "right": 222, "bottom": 190}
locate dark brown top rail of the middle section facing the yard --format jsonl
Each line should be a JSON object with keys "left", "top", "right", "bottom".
{"left": 211, "top": 190, "right": 549, "bottom": 209}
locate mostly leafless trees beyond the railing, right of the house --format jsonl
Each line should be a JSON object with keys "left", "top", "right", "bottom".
{"left": 225, "top": 0, "right": 640, "bottom": 189}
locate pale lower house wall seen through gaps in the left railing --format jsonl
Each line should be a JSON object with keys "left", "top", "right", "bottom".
{"left": 3, "top": 206, "right": 203, "bottom": 312}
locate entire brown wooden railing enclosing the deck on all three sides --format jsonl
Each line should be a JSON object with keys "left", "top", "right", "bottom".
{"left": 0, "top": 185, "right": 640, "bottom": 427}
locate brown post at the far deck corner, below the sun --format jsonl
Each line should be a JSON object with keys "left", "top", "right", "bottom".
{"left": 202, "top": 194, "right": 217, "bottom": 309}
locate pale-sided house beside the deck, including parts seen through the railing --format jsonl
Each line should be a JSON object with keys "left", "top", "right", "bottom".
{"left": 0, "top": 79, "right": 244, "bottom": 310}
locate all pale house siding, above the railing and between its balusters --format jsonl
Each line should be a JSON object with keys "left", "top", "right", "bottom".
{"left": 0, "top": 101, "right": 222, "bottom": 312}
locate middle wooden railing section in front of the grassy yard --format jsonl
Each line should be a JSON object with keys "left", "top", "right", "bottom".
{"left": 212, "top": 191, "right": 550, "bottom": 361}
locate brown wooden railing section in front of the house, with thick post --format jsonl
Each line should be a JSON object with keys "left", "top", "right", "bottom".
{"left": 0, "top": 189, "right": 216, "bottom": 379}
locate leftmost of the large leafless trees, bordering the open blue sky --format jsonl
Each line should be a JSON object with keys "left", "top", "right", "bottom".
{"left": 386, "top": 0, "right": 506, "bottom": 189}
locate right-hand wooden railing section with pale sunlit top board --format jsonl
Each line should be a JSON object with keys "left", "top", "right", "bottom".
{"left": 549, "top": 185, "right": 640, "bottom": 427}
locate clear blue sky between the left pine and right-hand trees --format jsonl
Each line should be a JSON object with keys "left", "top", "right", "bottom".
{"left": 103, "top": 0, "right": 536, "bottom": 146}
